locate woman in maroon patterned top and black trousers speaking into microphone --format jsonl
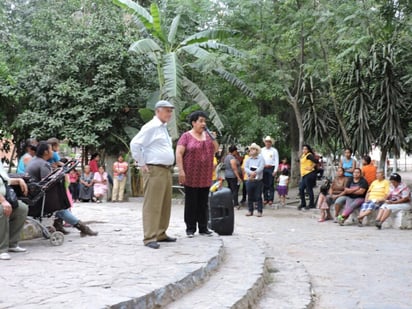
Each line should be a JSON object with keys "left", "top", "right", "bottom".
{"left": 176, "top": 111, "right": 219, "bottom": 237}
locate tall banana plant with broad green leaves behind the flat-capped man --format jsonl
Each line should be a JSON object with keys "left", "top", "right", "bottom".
{"left": 113, "top": 0, "right": 253, "bottom": 137}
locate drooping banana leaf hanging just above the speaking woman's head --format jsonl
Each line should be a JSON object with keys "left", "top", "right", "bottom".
{"left": 183, "top": 77, "right": 224, "bottom": 132}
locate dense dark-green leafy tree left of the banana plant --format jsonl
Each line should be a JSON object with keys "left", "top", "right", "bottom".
{"left": 7, "top": 0, "right": 153, "bottom": 153}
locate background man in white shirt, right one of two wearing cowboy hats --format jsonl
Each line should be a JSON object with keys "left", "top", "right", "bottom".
{"left": 261, "top": 136, "right": 279, "bottom": 205}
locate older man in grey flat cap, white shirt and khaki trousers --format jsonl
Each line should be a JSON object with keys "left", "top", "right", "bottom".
{"left": 130, "top": 100, "right": 176, "bottom": 249}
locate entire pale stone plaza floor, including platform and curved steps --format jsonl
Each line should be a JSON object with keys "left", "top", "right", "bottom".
{"left": 0, "top": 172, "right": 412, "bottom": 309}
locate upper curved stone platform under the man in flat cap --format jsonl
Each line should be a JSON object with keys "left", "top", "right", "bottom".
{"left": 0, "top": 203, "right": 224, "bottom": 309}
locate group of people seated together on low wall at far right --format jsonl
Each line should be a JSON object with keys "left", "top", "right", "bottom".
{"left": 317, "top": 153, "right": 411, "bottom": 229}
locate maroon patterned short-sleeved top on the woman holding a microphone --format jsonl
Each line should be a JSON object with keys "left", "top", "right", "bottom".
{"left": 177, "top": 132, "right": 215, "bottom": 188}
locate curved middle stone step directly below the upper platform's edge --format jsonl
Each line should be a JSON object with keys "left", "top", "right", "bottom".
{"left": 165, "top": 235, "right": 268, "bottom": 309}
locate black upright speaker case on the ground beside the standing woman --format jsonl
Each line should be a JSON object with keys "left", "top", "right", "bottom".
{"left": 209, "top": 188, "right": 235, "bottom": 235}
